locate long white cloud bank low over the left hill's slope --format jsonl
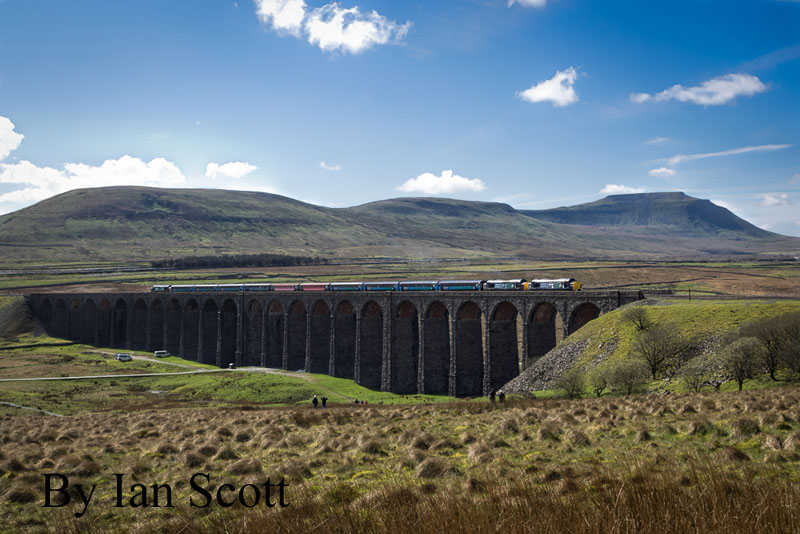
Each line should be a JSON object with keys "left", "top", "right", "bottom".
{"left": 0, "top": 155, "right": 186, "bottom": 209}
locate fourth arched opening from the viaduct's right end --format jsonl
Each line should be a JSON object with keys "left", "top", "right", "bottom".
{"left": 455, "top": 301, "right": 483, "bottom": 397}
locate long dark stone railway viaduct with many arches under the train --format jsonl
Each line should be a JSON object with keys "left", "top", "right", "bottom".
{"left": 28, "top": 291, "right": 642, "bottom": 397}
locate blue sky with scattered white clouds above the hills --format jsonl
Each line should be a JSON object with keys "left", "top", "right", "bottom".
{"left": 0, "top": 0, "right": 800, "bottom": 235}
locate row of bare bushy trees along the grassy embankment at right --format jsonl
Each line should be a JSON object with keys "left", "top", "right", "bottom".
{"left": 557, "top": 306, "right": 800, "bottom": 398}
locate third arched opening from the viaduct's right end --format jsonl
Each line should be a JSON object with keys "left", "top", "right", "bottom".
{"left": 489, "top": 301, "right": 520, "bottom": 389}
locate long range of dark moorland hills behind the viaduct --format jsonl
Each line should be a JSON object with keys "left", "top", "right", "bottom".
{"left": 0, "top": 187, "right": 800, "bottom": 265}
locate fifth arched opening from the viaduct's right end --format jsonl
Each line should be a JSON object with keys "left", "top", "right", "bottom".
{"left": 422, "top": 300, "right": 450, "bottom": 394}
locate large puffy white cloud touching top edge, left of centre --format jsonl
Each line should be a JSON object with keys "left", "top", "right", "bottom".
{"left": 256, "top": 0, "right": 411, "bottom": 54}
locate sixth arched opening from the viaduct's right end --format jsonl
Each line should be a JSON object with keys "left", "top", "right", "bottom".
{"left": 391, "top": 300, "right": 419, "bottom": 395}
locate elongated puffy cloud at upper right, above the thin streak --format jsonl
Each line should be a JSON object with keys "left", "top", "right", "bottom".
{"left": 630, "top": 74, "right": 767, "bottom": 106}
